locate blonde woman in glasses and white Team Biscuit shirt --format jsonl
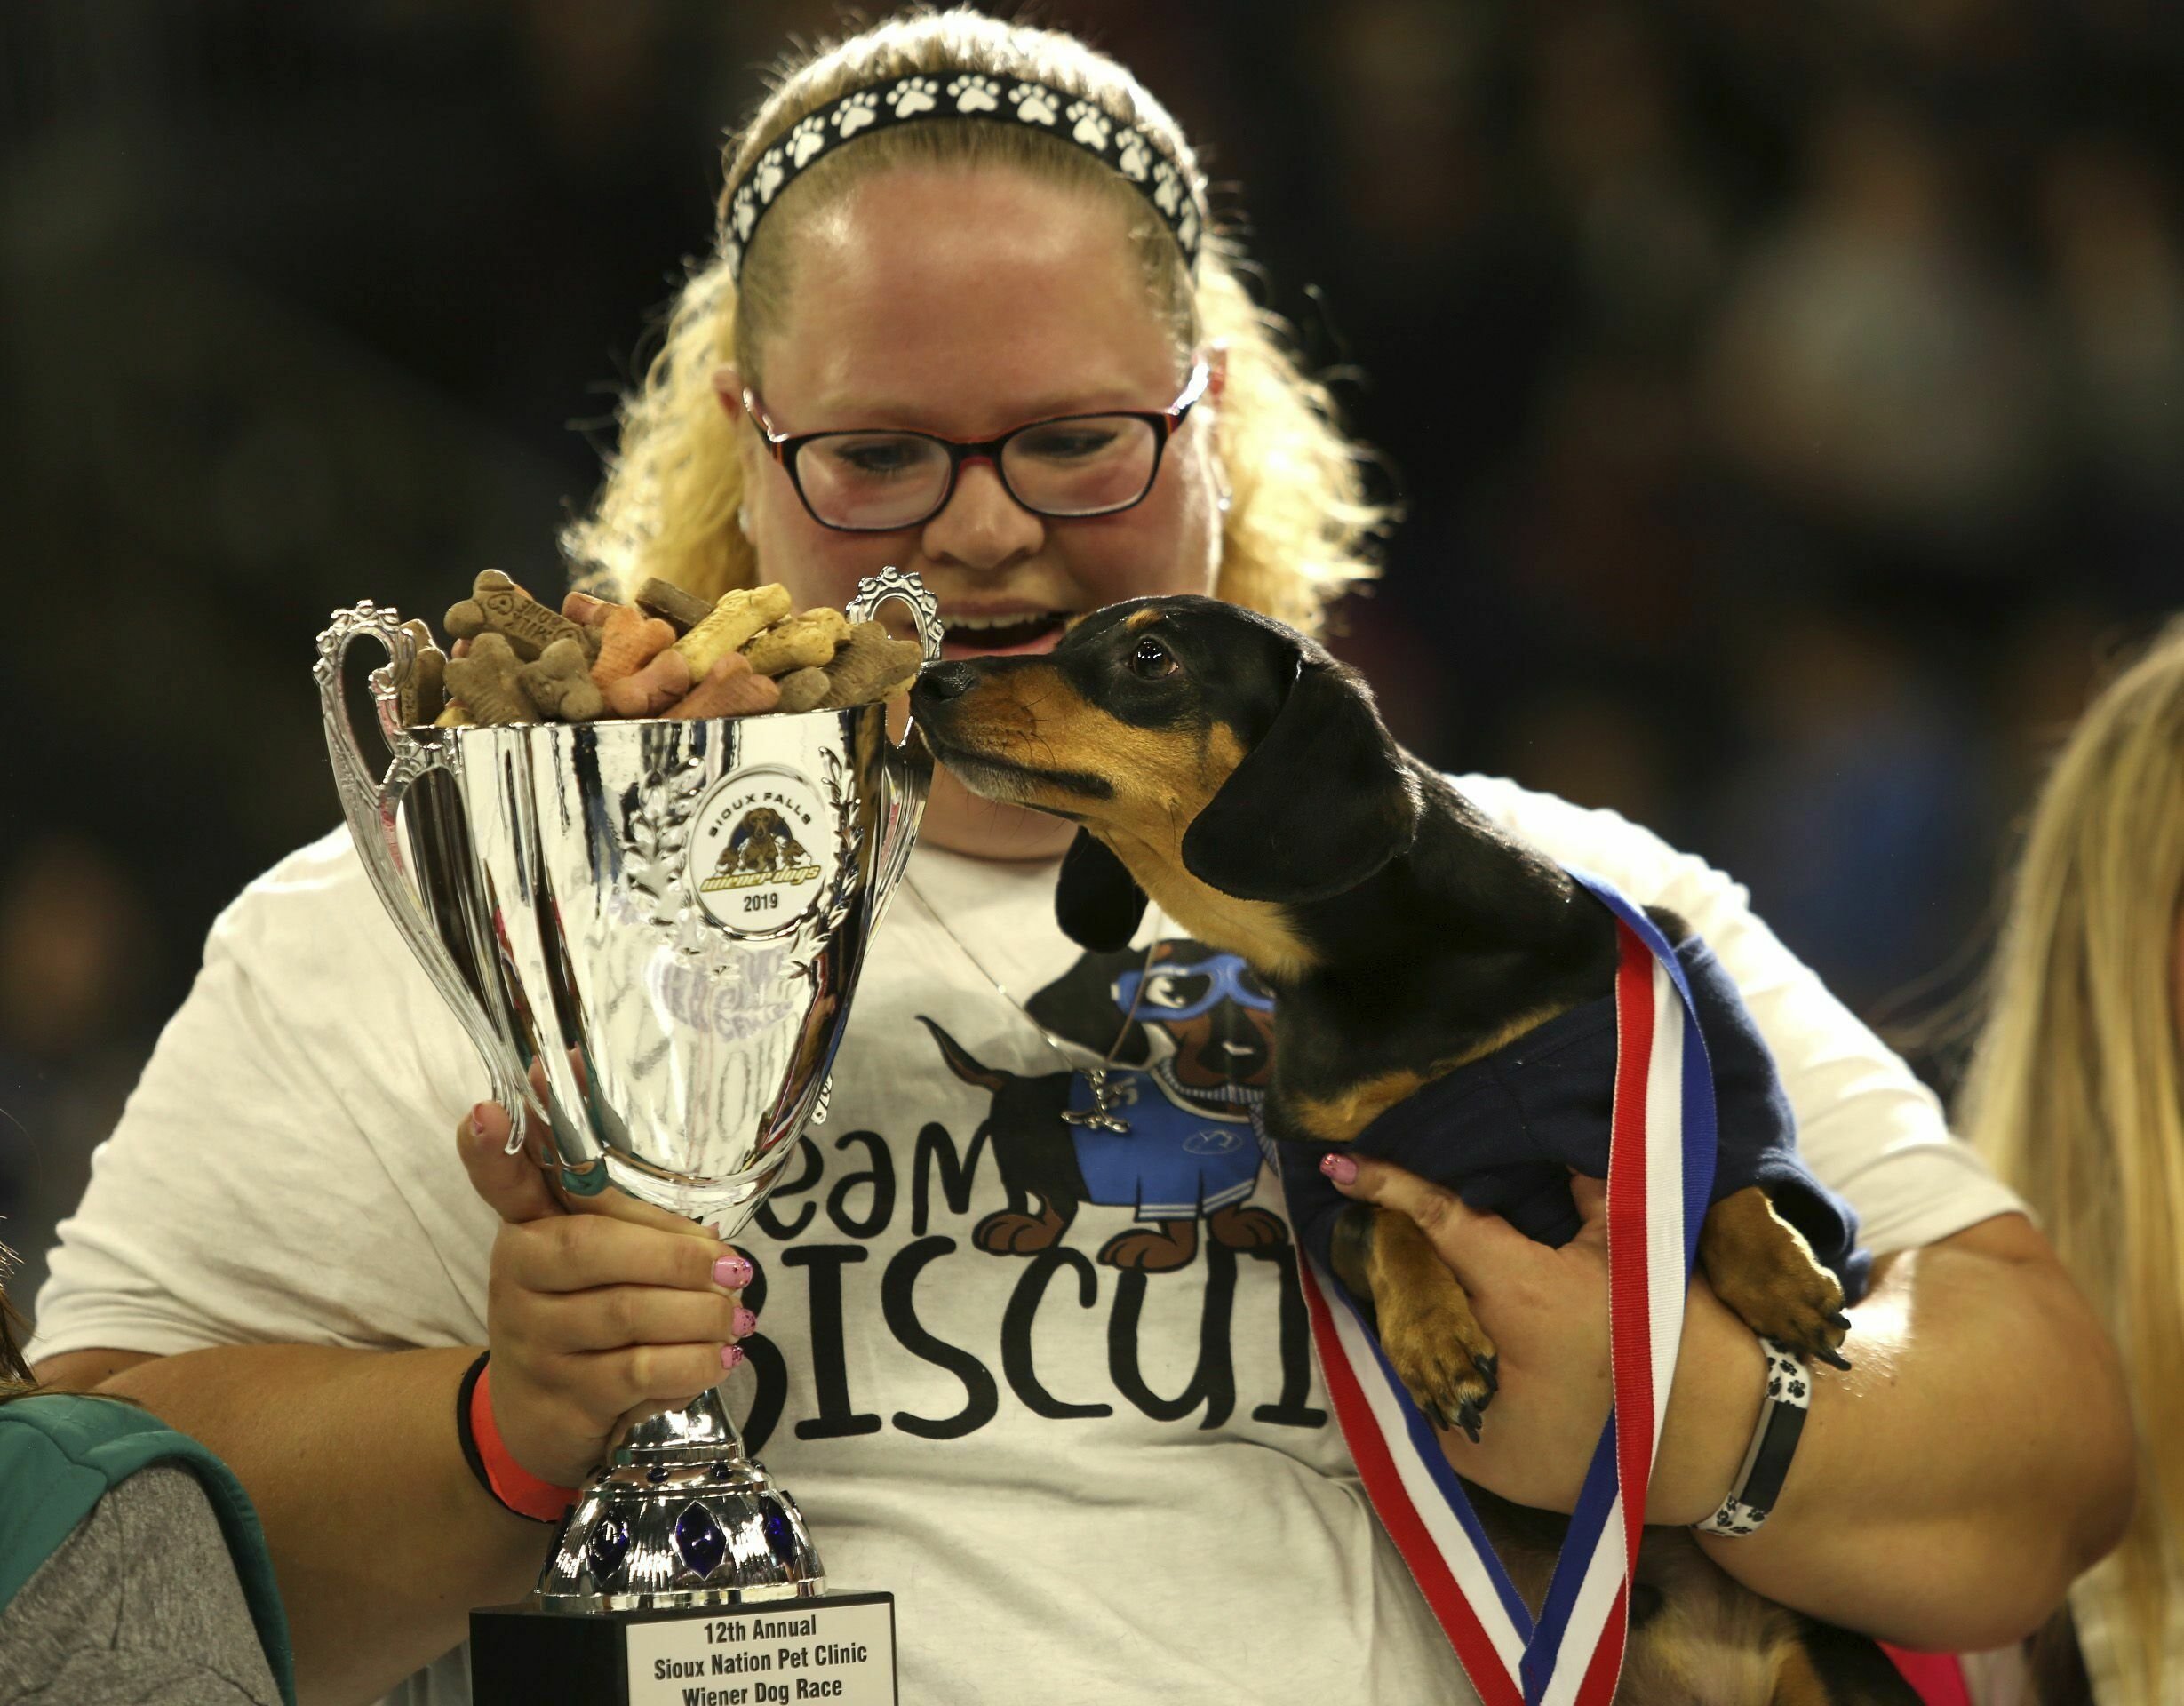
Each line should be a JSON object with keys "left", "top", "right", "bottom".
{"left": 25, "top": 13, "right": 2130, "bottom": 1702}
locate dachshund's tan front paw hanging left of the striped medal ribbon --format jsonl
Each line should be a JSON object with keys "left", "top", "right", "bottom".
{"left": 1332, "top": 1204, "right": 1501, "bottom": 1444}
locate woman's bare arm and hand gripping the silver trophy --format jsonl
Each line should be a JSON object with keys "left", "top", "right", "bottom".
{"left": 39, "top": 1107, "right": 749, "bottom": 1702}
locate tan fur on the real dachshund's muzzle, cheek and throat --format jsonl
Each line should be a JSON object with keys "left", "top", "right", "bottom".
{"left": 921, "top": 664, "right": 1315, "bottom": 978}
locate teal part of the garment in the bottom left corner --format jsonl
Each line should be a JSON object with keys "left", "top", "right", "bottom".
{"left": 0, "top": 1391, "right": 295, "bottom": 1706}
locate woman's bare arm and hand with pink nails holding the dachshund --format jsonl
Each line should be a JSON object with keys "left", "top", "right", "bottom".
{"left": 1336, "top": 1158, "right": 2133, "bottom": 1652}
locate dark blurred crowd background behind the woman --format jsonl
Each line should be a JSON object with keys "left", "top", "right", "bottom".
{"left": 0, "top": 0, "right": 2184, "bottom": 1304}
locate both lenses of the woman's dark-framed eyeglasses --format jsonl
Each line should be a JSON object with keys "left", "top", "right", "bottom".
{"left": 797, "top": 415, "right": 1160, "bottom": 529}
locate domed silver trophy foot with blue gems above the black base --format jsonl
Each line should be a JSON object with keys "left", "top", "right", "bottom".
{"left": 530, "top": 1387, "right": 825, "bottom": 1612}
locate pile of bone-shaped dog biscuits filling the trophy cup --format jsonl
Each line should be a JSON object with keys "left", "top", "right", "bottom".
{"left": 395, "top": 568, "right": 924, "bottom": 728}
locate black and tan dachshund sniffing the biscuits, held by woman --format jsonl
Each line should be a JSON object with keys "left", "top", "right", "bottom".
{"left": 911, "top": 596, "right": 1916, "bottom": 1706}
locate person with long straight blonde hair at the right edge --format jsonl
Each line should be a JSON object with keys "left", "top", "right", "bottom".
{"left": 1964, "top": 623, "right": 2184, "bottom": 1706}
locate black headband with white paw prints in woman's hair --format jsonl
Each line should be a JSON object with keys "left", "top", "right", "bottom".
{"left": 725, "top": 72, "right": 1206, "bottom": 277}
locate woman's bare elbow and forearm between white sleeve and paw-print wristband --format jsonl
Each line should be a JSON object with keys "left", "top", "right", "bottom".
{"left": 1699, "top": 1215, "right": 2136, "bottom": 1652}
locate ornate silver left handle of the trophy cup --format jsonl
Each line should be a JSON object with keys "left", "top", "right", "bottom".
{"left": 310, "top": 599, "right": 546, "bottom": 1155}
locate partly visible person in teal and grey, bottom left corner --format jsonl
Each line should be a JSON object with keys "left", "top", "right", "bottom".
{"left": 0, "top": 1245, "right": 295, "bottom": 1706}
